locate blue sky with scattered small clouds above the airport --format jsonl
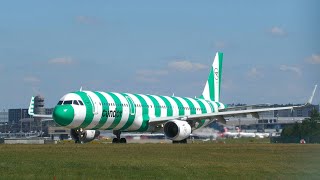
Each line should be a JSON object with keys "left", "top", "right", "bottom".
{"left": 0, "top": 0, "right": 320, "bottom": 109}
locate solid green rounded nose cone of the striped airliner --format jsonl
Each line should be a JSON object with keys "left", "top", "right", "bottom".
{"left": 52, "top": 105, "right": 74, "bottom": 126}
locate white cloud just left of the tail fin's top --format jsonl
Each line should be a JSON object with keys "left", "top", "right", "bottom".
{"left": 168, "top": 61, "right": 207, "bottom": 72}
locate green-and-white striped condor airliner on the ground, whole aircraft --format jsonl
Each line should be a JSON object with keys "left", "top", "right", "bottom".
{"left": 28, "top": 52, "right": 316, "bottom": 143}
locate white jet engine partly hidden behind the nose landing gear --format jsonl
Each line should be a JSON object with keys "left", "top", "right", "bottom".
{"left": 70, "top": 129, "right": 100, "bottom": 143}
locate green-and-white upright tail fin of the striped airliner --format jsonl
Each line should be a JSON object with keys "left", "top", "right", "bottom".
{"left": 200, "top": 52, "right": 223, "bottom": 102}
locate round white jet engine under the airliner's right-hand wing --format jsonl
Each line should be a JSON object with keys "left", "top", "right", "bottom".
{"left": 163, "top": 120, "right": 191, "bottom": 141}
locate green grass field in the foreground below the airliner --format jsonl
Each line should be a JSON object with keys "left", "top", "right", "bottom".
{"left": 0, "top": 143, "right": 320, "bottom": 180}
